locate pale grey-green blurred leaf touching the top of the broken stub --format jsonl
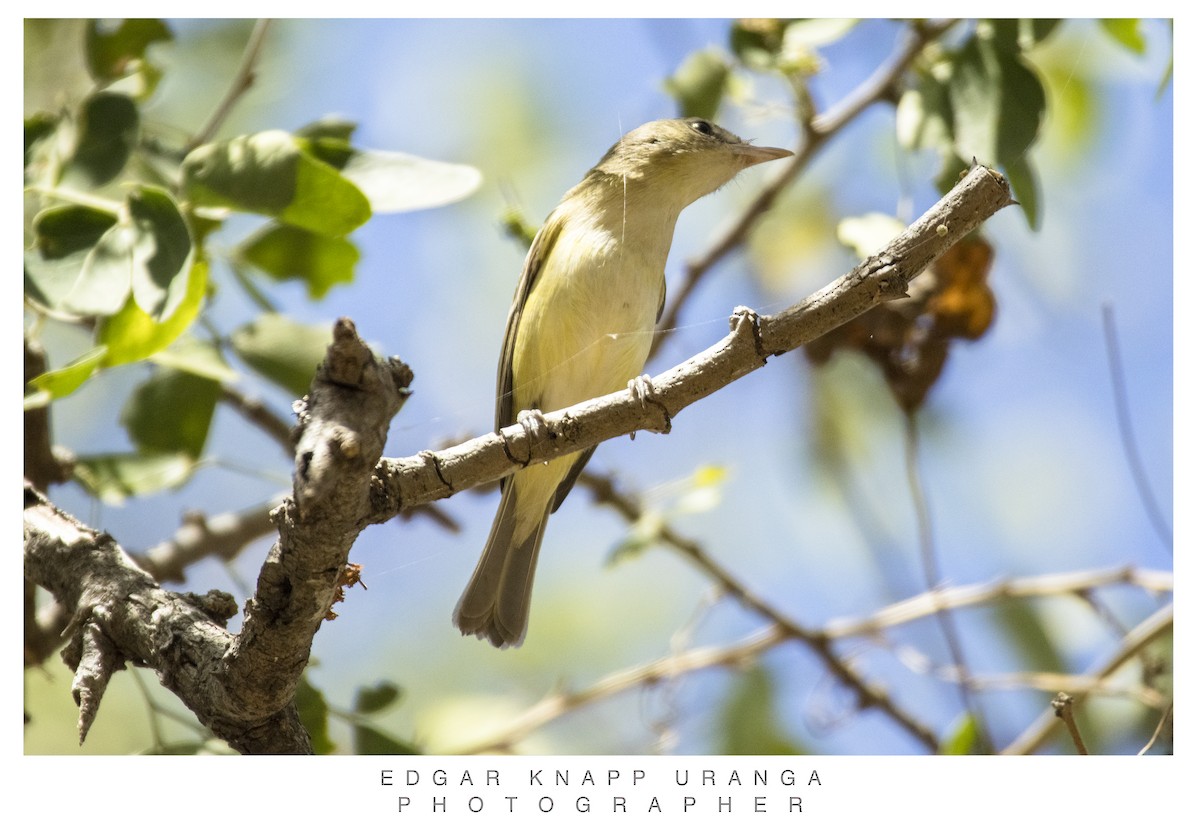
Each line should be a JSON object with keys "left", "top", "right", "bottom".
{"left": 230, "top": 313, "right": 332, "bottom": 396}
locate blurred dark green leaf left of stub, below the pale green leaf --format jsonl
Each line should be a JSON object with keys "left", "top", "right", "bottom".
{"left": 121, "top": 368, "right": 221, "bottom": 459}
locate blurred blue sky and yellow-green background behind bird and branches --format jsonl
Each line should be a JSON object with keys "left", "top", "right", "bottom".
{"left": 25, "top": 19, "right": 1174, "bottom": 754}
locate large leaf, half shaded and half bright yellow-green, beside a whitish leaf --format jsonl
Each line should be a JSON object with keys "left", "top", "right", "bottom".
{"left": 182, "top": 131, "right": 371, "bottom": 236}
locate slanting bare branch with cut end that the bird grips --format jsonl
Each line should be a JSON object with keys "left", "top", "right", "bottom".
{"left": 370, "top": 166, "right": 1014, "bottom": 522}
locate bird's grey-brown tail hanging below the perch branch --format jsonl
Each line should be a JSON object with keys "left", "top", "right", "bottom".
{"left": 454, "top": 480, "right": 550, "bottom": 649}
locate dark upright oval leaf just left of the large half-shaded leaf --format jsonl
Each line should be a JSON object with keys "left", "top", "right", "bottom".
{"left": 62, "top": 92, "right": 139, "bottom": 190}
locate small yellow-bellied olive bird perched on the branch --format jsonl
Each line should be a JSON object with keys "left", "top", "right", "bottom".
{"left": 454, "top": 118, "right": 791, "bottom": 647}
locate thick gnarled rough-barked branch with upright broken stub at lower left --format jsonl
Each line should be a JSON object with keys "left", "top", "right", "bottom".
{"left": 24, "top": 319, "right": 412, "bottom": 753}
